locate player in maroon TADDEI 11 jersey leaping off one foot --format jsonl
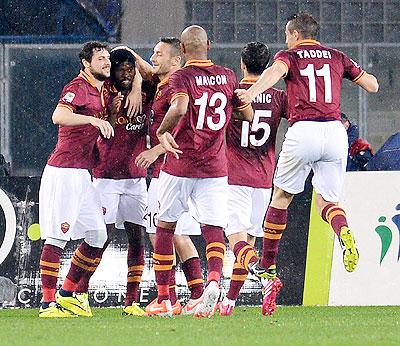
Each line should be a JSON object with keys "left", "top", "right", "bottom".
{"left": 237, "top": 12, "right": 379, "bottom": 314}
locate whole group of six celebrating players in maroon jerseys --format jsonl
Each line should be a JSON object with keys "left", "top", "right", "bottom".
{"left": 39, "top": 12, "right": 378, "bottom": 317}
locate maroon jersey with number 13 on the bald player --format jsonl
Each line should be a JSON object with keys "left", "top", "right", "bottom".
{"left": 161, "top": 60, "right": 250, "bottom": 178}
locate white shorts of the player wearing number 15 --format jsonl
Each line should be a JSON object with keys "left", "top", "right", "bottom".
{"left": 225, "top": 185, "right": 272, "bottom": 237}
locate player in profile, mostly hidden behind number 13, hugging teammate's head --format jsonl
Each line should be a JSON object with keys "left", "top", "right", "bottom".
{"left": 135, "top": 37, "right": 203, "bottom": 315}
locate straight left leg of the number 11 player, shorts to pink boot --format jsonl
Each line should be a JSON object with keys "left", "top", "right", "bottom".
{"left": 255, "top": 122, "right": 323, "bottom": 315}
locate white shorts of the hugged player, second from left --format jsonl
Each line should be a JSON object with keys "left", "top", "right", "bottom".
{"left": 93, "top": 178, "right": 147, "bottom": 229}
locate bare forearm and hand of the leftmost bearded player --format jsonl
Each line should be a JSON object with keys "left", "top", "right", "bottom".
{"left": 52, "top": 106, "right": 114, "bottom": 138}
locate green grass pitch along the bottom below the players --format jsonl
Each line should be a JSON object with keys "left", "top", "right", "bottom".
{"left": 0, "top": 307, "right": 400, "bottom": 346}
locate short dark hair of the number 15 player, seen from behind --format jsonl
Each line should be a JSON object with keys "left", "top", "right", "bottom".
{"left": 241, "top": 42, "right": 271, "bottom": 75}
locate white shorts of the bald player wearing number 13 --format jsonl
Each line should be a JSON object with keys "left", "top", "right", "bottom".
{"left": 158, "top": 171, "right": 229, "bottom": 228}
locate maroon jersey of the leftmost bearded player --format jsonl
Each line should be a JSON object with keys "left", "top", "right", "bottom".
{"left": 47, "top": 71, "right": 107, "bottom": 169}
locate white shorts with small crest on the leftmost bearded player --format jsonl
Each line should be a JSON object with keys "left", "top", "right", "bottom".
{"left": 39, "top": 165, "right": 107, "bottom": 240}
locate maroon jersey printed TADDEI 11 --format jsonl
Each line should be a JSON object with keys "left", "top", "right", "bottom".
{"left": 274, "top": 40, "right": 364, "bottom": 125}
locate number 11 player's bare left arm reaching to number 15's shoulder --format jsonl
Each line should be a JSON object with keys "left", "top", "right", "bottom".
{"left": 235, "top": 61, "right": 288, "bottom": 103}
